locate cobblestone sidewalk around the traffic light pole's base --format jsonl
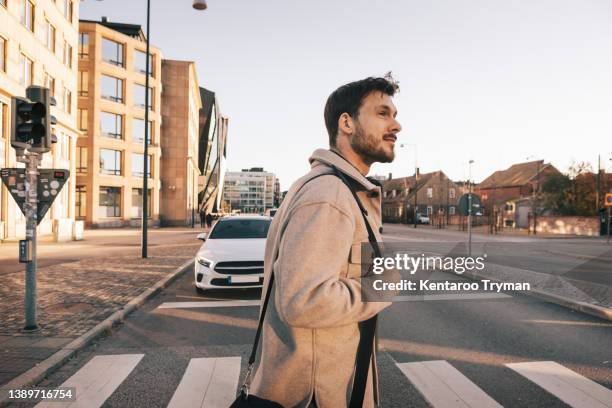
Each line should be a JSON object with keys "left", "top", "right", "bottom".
{"left": 0, "top": 231, "right": 201, "bottom": 384}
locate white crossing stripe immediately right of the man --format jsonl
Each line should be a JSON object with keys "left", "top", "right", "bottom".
{"left": 396, "top": 360, "right": 501, "bottom": 408}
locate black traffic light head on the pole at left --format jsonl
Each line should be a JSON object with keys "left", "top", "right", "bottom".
{"left": 11, "top": 86, "right": 57, "bottom": 155}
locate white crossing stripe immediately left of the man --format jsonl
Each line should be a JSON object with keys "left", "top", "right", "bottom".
{"left": 168, "top": 357, "right": 240, "bottom": 408}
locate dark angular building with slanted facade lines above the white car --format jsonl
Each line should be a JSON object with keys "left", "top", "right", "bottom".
{"left": 198, "top": 87, "right": 229, "bottom": 214}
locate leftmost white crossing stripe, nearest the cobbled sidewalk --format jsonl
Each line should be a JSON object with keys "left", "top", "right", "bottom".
{"left": 36, "top": 354, "right": 144, "bottom": 408}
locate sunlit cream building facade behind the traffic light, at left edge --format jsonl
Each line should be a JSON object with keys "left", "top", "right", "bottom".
{"left": 0, "top": 0, "right": 80, "bottom": 240}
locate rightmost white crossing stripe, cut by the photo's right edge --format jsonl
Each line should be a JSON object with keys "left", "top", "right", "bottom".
{"left": 506, "top": 361, "right": 612, "bottom": 408}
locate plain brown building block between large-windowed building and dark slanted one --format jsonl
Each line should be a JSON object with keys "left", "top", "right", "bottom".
{"left": 161, "top": 60, "right": 202, "bottom": 225}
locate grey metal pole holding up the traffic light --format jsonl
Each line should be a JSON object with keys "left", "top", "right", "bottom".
{"left": 23, "top": 152, "right": 39, "bottom": 331}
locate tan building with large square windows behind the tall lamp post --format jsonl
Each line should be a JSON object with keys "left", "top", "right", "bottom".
{"left": 75, "top": 18, "right": 162, "bottom": 228}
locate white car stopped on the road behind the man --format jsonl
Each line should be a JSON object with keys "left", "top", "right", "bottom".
{"left": 194, "top": 215, "right": 272, "bottom": 293}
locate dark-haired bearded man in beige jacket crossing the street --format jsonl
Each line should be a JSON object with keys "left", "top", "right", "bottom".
{"left": 250, "top": 76, "right": 401, "bottom": 408}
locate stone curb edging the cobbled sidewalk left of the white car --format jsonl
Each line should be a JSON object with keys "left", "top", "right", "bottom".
{"left": 0, "top": 260, "right": 194, "bottom": 407}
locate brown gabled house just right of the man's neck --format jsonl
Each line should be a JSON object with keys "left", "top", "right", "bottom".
{"left": 382, "top": 171, "right": 462, "bottom": 223}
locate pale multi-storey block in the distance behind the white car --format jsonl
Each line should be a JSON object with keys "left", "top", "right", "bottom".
{"left": 223, "top": 167, "right": 276, "bottom": 213}
